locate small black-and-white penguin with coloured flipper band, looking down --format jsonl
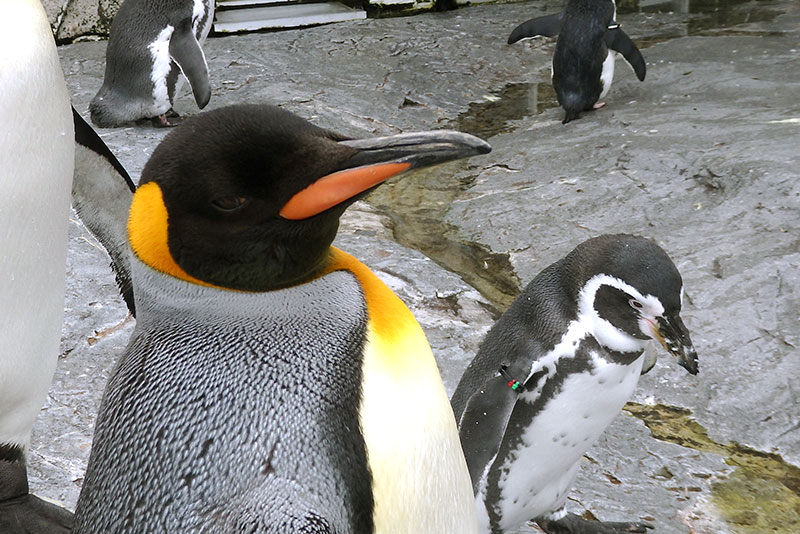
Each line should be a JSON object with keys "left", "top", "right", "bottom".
{"left": 452, "top": 234, "right": 697, "bottom": 534}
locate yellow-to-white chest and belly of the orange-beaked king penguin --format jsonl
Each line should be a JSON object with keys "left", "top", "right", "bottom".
{"left": 331, "top": 249, "right": 477, "bottom": 534}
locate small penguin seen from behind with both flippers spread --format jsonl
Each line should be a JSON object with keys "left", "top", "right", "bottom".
{"left": 508, "top": 0, "right": 647, "bottom": 124}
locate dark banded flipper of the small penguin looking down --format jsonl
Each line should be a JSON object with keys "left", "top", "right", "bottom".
{"left": 461, "top": 376, "right": 519, "bottom": 493}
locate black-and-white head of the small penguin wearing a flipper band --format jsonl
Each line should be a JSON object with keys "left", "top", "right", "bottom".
{"left": 567, "top": 234, "right": 697, "bottom": 374}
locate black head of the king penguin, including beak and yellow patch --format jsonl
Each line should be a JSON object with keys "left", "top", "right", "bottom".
{"left": 128, "top": 105, "right": 490, "bottom": 291}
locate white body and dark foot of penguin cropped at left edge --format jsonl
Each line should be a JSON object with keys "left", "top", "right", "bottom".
{"left": 0, "top": 0, "right": 74, "bottom": 534}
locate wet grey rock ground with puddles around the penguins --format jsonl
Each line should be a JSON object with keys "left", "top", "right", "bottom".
{"left": 30, "top": 0, "right": 800, "bottom": 534}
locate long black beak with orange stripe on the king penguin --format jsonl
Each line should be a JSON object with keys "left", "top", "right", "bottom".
{"left": 280, "top": 130, "right": 491, "bottom": 220}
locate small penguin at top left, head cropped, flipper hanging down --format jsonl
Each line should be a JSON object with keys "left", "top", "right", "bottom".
{"left": 89, "top": 0, "right": 214, "bottom": 128}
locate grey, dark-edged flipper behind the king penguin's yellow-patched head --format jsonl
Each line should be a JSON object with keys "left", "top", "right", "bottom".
{"left": 72, "top": 107, "right": 136, "bottom": 315}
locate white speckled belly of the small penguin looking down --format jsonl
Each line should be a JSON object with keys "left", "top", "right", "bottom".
{"left": 499, "top": 356, "right": 643, "bottom": 526}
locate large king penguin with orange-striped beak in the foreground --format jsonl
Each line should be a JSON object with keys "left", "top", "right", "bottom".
{"left": 74, "top": 105, "right": 490, "bottom": 534}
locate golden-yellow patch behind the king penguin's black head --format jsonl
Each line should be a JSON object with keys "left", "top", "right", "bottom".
{"left": 128, "top": 182, "right": 217, "bottom": 287}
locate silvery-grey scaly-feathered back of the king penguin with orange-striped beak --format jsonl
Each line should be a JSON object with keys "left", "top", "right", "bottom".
{"left": 74, "top": 261, "right": 372, "bottom": 534}
